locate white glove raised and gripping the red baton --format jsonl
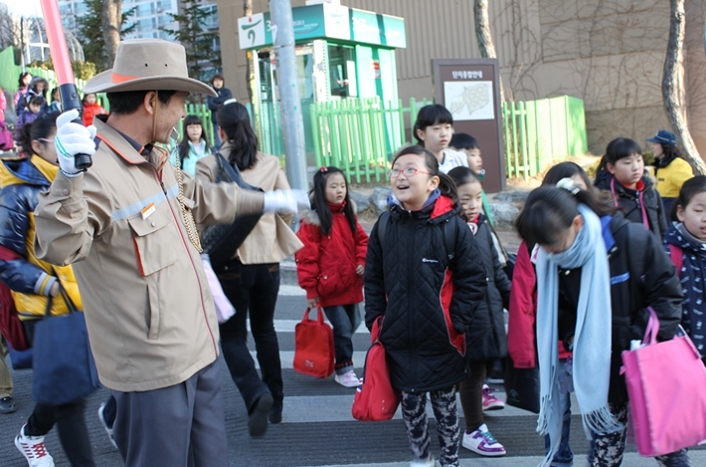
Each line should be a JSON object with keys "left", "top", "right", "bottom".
{"left": 54, "top": 109, "right": 96, "bottom": 177}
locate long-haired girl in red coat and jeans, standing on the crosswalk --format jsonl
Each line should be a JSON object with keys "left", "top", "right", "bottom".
{"left": 295, "top": 167, "right": 368, "bottom": 388}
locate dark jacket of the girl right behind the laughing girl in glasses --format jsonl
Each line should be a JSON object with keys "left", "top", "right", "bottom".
{"left": 466, "top": 214, "right": 511, "bottom": 361}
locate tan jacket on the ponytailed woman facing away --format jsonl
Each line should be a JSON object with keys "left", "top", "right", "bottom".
{"left": 196, "top": 147, "right": 304, "bottom": 264}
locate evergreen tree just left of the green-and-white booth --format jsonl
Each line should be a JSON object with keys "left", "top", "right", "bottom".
{"left": 160, "top": 0, "right": 221, "bottom": 80}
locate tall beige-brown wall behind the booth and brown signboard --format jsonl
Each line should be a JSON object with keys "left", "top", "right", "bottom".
{"left": 218, "top": 0, "right": 706, "bottom": 159}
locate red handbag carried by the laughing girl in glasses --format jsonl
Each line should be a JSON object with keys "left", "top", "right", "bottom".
{"left": 351, "top": 316, "right": 400, "bottom": 422}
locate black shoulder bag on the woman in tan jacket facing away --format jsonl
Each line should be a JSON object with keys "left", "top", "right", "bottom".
{"left": 201, "top": 152, "right": 263, "bottom": 273}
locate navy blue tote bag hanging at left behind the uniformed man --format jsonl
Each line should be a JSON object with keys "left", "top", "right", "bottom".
{"left": 32, "top": 285, "right": 100, "bottom": 406}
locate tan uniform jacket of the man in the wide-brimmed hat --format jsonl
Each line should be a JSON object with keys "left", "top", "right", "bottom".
{"left": 35, "top": 119, "right": 263, "bottom": 392}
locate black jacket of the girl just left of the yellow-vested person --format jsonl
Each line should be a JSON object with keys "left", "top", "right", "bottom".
{"left": 595, "top": 171, "right": 667, "bottom": 239}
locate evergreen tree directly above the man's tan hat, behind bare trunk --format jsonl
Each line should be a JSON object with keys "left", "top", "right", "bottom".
{"left": 76, "top": 0, "right": 137, "bottom": 72}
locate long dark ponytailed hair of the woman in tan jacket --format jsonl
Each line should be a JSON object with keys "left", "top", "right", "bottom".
{"left": 214, "top": 101, "right": 257, "bottom": 170}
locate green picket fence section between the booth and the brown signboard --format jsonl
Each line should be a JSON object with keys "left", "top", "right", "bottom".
{"left": 310, "top": 98, "right": 427, "bottom": 183}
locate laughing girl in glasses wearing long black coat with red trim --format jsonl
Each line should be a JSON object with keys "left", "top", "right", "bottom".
{"left": 364, "top": 146, "right": 486, "bottom": 467}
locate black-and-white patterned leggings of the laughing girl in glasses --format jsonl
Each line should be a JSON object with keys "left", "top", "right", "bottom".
{"left": 402, "top": 386, "right": 461, "bottom": 467}
